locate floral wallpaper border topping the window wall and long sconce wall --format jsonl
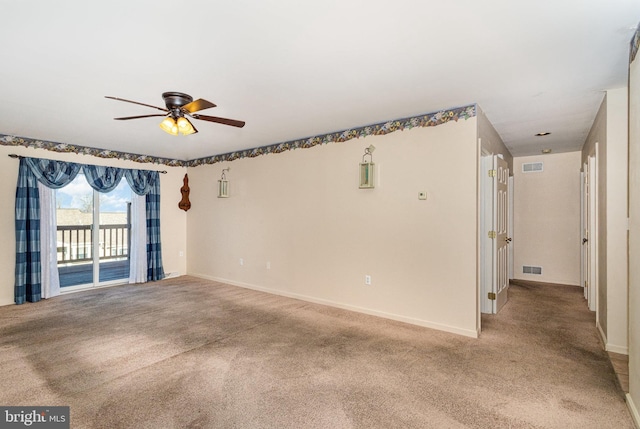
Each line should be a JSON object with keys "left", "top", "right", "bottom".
{"left": 0, "top": 104, "right": 476, "bottom": 167}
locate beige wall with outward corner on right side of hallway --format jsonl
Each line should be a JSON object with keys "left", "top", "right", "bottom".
{"left": 582, "top": 88, "right": 628, "bottom": 354}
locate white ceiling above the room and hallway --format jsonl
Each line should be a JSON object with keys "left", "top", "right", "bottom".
{"left": 0, "top": 0, "right": 640, "bottom": 160}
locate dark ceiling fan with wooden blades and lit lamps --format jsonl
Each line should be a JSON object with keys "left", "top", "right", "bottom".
{"left": 105, "top": 92, "right": 244, "bottom": 136}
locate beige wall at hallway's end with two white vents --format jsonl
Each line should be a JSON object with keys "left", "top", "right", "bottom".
{"left": 513, "top": 152, "right": 580, "bottom": 285}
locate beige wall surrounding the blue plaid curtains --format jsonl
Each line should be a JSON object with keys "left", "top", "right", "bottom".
{"left": 0, "top": 146, "right": 187, "bottom": 305}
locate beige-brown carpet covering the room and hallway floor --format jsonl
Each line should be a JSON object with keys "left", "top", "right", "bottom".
{"left": 0, "top": 276, "right": 634, "bottom": 429}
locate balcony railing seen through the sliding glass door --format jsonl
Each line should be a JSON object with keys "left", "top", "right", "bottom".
{"left": 57, "top": 224, "right": 131, "bottom": 264}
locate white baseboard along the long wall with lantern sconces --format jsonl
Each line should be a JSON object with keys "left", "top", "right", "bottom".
{"left": 188, "top": 273, "right": 478, "bottom": 338}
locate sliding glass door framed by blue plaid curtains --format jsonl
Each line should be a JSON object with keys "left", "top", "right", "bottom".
{"left": 56, "top": 173, "right": 131, "bottom": 290}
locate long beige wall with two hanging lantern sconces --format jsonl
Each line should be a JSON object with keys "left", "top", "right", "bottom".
{"left": 187, "top": 118, "right": 478, "bottom": 336}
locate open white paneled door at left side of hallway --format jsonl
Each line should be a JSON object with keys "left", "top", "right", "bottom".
{"left": 493, "top": 156, "right": 511, "bottom": 313}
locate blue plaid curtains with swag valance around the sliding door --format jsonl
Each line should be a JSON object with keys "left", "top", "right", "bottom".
{"left": 15, "top": 158, "right": 164, "bottom": 304}
